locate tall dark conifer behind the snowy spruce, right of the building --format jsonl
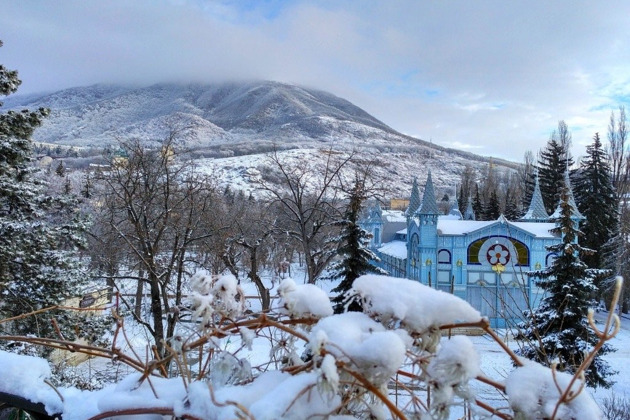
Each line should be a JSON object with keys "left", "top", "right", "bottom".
{"left": 574, "top": 133, "right": 618, "bottom": 268}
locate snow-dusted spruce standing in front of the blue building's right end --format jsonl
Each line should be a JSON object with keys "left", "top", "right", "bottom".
{"left": 517, "top": 177, "right": 613, "bottom": 387}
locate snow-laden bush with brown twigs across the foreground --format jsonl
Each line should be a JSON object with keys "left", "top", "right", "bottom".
{"left": 0, "top": 273, "right": 614, "bottom": 420}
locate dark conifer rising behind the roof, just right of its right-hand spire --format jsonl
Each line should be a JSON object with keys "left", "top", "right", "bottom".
{"left": 540, "top": 126, "right": 573, "bottom": 214}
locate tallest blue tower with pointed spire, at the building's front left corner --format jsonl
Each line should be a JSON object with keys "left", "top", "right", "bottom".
{"left": 415, "top": 171, "right": 440, "bottom": 287}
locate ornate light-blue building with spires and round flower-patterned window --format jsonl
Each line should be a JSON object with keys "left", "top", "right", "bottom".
{"left": 362, "top": 173, "right": 583, "bottom": 327}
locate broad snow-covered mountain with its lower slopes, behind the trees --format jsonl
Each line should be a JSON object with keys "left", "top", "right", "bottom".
{"left": 2, "top": 81, "right": 514, "bottom": 199}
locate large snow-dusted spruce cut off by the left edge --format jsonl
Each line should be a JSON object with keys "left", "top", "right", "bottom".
{"left": 0, "top": 43, "right": 91, "bottom": 346}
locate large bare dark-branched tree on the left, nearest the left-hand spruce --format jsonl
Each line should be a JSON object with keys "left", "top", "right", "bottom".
{"left": 94, "top": 134, "right": 220, "bottom": 356}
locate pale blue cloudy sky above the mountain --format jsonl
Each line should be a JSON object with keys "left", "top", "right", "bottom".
{"left": 0, "top": 0, "right": 630, "bottom": 161}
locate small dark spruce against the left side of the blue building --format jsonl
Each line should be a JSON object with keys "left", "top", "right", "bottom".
{"left": 329, "top": 176, "right": 387, "bottom": 313}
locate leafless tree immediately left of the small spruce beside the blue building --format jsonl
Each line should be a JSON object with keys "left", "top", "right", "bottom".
{"left": 258, "top": 151, "right": 354, "bottom": 283}
